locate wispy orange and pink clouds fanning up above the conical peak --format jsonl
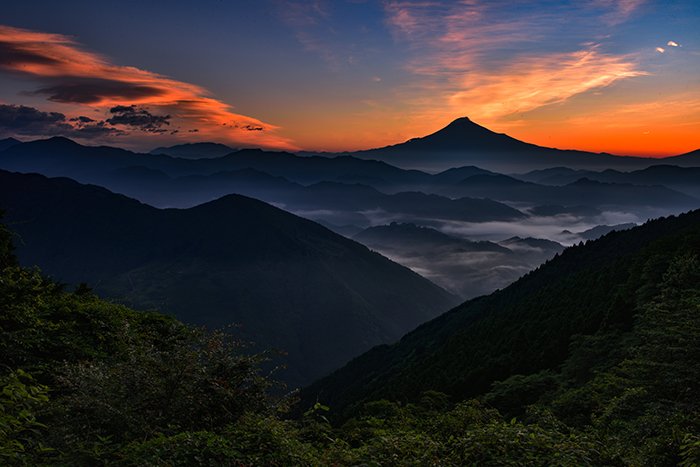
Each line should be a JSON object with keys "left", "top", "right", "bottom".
{"left": 385, "top": 0, "right": 645, "bottom": 126}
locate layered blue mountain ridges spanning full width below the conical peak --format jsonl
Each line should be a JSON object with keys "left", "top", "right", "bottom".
{"left": 0, "top": 138, "right": 700, "bottom": 228}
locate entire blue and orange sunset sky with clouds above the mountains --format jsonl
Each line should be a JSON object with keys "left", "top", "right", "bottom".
{"left": 0, "top": 0, "right": 700, "bottom": 156}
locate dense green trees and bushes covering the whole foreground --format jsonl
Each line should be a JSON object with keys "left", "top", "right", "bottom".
{"left": 0, "top": 213, "right": 700, "bottom": 466}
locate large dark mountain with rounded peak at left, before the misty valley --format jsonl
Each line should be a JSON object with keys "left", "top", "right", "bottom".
{"left": 0, "top": 171, "right": 455, "bottom": 384}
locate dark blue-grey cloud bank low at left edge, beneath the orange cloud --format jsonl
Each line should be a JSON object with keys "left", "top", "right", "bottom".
{"left": 0, "top": 104, "right": 122, "bottom": 138}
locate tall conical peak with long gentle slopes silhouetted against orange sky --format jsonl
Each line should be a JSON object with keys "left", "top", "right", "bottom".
{"left": 353, "top": 117, "right": 688, "bottom": 172}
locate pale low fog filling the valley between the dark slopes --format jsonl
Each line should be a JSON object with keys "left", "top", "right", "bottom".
{"left": 297, "top": 206, "right": 688, "bottom": 299}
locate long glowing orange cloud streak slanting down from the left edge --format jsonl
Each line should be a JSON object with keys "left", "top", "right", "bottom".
{"left": 0, "top": 26, "right": 295, "bottom": 149}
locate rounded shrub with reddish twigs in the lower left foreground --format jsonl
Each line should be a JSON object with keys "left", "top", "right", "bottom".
{"left": 53, "top": 330, "right": 272, "bottom": 454}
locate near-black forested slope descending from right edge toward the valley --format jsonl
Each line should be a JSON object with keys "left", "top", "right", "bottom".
{"left": 305, "top": 211, "right": 700, "bottom": 411}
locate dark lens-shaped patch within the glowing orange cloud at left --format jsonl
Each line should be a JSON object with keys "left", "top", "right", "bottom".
{"left": 29, "top": 78, "right": 164, "bottom": 104}
